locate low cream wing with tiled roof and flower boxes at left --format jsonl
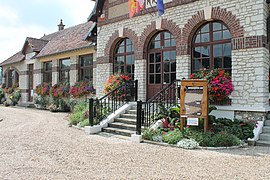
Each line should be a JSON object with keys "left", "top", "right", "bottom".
{"left": 0, "top": 20, "right": 96, "bottom": 105}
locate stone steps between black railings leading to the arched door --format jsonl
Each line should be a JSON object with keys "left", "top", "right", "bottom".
{"left": 102, "top": 106, "right": 137, "bottom": 137}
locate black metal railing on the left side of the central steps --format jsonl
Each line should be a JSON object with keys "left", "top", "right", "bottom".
{"left": 89, "top": 80, "right": 138, "bottom": 126}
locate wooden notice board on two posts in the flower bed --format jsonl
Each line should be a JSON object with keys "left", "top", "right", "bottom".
{"left": 180, "top": 79, "right": 209, "bottom": 132}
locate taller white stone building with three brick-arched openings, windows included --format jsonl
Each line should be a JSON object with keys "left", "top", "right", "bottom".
{"left": 88, "top": 0, "right": 270, "bottom": 119}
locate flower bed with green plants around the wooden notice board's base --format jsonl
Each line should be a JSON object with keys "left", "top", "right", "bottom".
{"left": 143, "top": 107, "right": 256, "bottom": 149}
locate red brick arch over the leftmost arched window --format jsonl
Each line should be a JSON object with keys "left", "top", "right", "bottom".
{"left": 105, "top": 28, "right": 138, "bottom": 62}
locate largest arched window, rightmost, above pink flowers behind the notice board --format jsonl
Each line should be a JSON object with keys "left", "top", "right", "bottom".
{"left": 192, "top": 22, "right": 232, "bottom": 73}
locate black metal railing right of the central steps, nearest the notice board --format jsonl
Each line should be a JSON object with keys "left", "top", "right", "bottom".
{"left": 136, "top": 80, "right": 181, "bottom": 135}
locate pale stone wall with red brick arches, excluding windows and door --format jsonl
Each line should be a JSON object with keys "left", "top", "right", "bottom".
{"left": 96, "top": 0, "right": 269, "bottom": 118}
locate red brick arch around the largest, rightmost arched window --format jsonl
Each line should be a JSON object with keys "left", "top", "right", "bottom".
{"left": 180, "top": 7, "right": 244, "bottom": 54}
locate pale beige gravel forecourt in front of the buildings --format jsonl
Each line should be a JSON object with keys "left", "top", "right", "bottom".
{"left": 0, "top": 106, "right": 270, "bottom": 180}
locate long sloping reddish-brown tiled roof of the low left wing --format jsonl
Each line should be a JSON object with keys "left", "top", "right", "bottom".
{"left": 36, "top": 21, "right": 93, "bottom": 58}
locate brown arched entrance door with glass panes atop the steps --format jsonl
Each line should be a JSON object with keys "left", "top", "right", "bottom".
{"left": 147, "top": 31, "right": 176, "bottom": 99}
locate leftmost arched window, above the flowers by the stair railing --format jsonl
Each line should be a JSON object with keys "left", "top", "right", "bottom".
{"left": 113, "top": 38, "right": 134, "bottom": 79}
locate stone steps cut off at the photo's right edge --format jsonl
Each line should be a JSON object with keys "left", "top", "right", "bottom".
{"left": 256, "top": 114, "right": 270, "bottom": 146}
